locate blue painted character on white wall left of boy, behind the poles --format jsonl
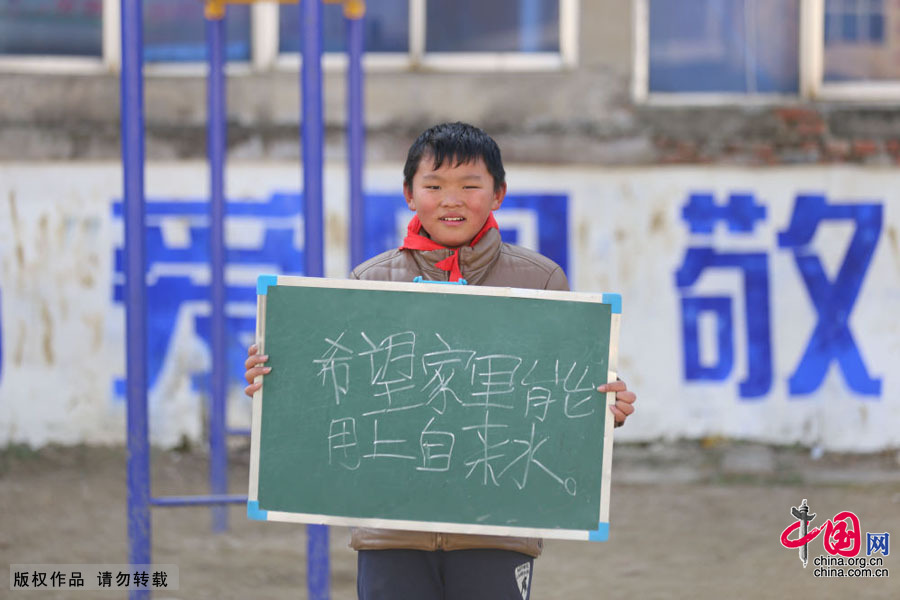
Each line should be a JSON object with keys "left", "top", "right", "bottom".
{"left": 113, "top": 192, "right": 304, "bottom": 399}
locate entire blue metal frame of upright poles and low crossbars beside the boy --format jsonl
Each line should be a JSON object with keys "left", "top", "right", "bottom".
{"left": 121, "top": 0, "right": 365, "bottom": 600}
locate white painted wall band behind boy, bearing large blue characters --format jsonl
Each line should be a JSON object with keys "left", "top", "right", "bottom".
{"left": 0, "top": 163, "right": 900, "bottom": 451}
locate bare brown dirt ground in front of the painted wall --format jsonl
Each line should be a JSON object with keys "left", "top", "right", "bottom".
{"left": 0, "top": 440, "right": 900, "bottom": 600}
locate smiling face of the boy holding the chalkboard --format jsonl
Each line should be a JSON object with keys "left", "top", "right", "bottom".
{"left": 403, "top": 155, "right": 506, "bottom": 248}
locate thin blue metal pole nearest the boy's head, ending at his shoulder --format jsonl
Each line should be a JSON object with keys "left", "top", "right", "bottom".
{"left": 345, "top": 9, "right": 366, "bottom": 266}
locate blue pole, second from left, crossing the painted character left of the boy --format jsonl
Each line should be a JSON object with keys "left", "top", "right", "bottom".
{"left": 206, "top": 11, "right": 228, "bottom": 532}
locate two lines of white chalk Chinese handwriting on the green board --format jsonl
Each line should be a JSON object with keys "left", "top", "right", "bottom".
{"left": 312, "top": 331, "right": 607, "bottom": 496}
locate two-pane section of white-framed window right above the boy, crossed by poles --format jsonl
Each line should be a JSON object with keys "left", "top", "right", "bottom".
{"left": 277, "top": 0, "right": 580, "bottom": 70}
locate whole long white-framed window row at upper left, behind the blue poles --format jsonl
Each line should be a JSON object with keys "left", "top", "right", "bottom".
{"left": 0, "top": 0, "right": 581, "bottom": 74}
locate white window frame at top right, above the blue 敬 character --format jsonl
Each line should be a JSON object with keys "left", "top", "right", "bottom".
{"left": 631, "top": 0, "right": 900, "bottom": 106}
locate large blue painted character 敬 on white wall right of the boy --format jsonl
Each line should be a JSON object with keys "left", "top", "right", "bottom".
{"left": 675, "top": 193, "right": 883, "bottom": 399}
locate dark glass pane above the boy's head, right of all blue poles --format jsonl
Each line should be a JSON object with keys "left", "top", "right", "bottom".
{"left": 425, "top": 0, "right": 559, "bottom": 52}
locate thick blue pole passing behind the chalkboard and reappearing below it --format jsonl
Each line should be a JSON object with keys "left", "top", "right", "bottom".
{"left": 300, "top": 0, "right": 329, "bottom": 600}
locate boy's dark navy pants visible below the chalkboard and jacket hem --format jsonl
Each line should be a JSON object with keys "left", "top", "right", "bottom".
{"left": 356, "top": 550, "right": 534, "bottom": 600}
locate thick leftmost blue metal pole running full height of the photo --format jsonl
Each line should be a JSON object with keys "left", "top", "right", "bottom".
{"left": 121, "top": 0, "right": 152, "bottom": 599}
